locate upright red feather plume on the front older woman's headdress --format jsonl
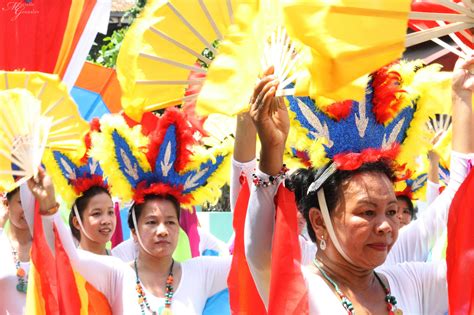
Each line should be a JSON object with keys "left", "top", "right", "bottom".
{"left": 372, "top": 65, "right": 406, "bottom": 124}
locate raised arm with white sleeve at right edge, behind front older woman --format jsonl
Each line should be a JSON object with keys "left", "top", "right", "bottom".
{"left": 385, "top": 59, "right": 474, "bottom": 265}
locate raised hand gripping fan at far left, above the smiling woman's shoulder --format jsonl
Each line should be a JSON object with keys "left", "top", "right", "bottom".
{"left": 28, "top": 167, "right": 57, "bottom": 212}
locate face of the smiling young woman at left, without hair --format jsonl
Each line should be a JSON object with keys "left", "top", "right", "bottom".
{"left": 77, "top": 193, "right": 117, "bottom": 244}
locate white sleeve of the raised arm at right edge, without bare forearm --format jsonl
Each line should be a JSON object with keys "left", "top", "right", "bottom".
{"left": 384, "top": 152, "right": 469, "bottom": 265}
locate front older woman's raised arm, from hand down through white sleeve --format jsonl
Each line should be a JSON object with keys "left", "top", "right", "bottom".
{"left": 245, "top": 68, "right": 289, "bottom": 306}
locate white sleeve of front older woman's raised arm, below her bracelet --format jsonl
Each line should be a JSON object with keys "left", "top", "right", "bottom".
{"left": 244, "top": 170, "right": 279, "bottom": 308}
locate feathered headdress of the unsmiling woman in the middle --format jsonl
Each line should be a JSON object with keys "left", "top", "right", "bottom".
{"left": 91, "top": 108, "right": 228, "bottom": 207}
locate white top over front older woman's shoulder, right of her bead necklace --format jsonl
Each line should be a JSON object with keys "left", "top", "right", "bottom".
{"left": 380, "top": 261, "right": 448, "bottom": 314}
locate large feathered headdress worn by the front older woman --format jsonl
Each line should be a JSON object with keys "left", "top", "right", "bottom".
{"left": 287, "top": 62, "right": 448, "bottom": 177}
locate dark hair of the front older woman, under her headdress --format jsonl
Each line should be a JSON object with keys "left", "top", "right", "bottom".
{"left": 290, "top": 160, "right": 395, "bottom": 242}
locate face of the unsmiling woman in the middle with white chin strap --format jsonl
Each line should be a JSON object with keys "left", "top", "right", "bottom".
{"left": 134, "top": 199, "right": 179, "bottom": 257}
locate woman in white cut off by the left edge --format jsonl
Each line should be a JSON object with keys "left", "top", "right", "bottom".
{"left": 0, "top": 188, "right": 32, "bottom": 315}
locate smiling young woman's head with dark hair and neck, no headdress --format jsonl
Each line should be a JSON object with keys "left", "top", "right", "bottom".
{"left": 69, "top": 186, "right": 117, "bottom": 255}
